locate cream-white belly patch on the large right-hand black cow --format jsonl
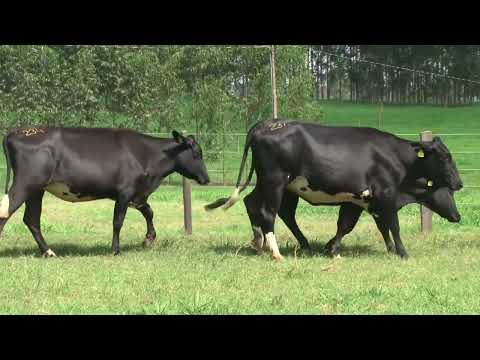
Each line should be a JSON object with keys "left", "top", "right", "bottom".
{"left": 287, "top": 176, "right": 370, "bottom": 209}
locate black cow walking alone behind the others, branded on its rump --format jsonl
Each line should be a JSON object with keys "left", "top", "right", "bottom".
{"left": 0, "top": 127, "right": 209, "bottom": 256}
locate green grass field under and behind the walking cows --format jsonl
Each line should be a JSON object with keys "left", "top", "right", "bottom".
{"left": 0, "top": 100, "right": 480, "bottom": 314}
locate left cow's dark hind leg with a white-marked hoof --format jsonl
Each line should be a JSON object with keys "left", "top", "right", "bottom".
{"left": 23, "top": 190, "right": 56, "bottom": 257}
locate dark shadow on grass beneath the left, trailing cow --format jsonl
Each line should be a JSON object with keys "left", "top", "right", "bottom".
{"left": 0, "top": 242, "right": 149, "bottom": 258}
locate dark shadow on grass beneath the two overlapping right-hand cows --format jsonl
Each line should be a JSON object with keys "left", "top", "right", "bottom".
{"left": 212, "top": 242, "right": 387, "bottom": 258}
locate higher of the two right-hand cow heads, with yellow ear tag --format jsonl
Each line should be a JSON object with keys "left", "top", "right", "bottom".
{"left": 412, "top": 137, "right": 463, "bottom": 191}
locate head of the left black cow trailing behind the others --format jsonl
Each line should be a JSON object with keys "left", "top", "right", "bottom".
{"left": 172, "top": 130, "right": 210, "bottom": 185}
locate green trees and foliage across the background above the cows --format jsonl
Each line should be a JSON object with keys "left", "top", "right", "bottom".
{"left": 0, "top": 45, "right": 480, "bottom": 133}
